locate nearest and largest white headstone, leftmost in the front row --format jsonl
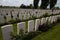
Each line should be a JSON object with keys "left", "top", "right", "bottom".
{"left": 1, "top": 25, "right": 13, "bottom": 40}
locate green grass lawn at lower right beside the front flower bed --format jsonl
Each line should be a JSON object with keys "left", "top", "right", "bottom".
{"left": 32, "top": 23, "right": 60, "bottom": 40}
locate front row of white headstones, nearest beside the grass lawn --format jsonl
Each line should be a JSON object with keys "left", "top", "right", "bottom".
{"left": 1, "top": 15, "right": 60, "bottom": 40}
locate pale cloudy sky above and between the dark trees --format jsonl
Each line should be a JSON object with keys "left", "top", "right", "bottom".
{"left": 0, "top": 0, "right": 60, "bottom": 7}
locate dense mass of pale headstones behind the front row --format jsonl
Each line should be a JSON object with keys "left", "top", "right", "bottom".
{"left": 0, "top": 8, "right": 60, "bottom": 23}
